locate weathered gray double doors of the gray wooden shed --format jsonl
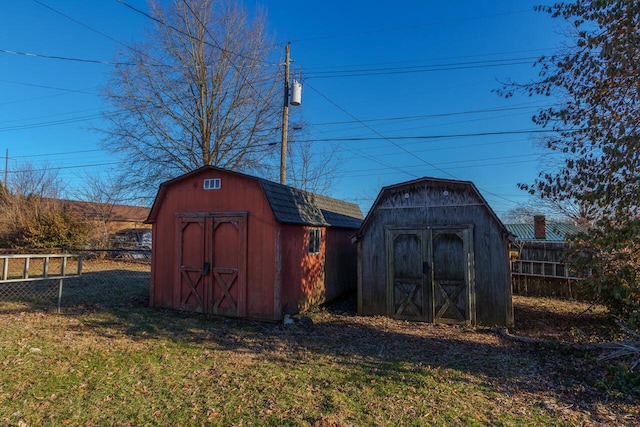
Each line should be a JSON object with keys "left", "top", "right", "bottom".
{"left": 386, "top": 227, "right": 475, "bottom": 324}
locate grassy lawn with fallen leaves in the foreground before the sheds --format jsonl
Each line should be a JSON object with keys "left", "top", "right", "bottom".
{"left": 0, "top": 299, "right": 640, "bottom": 426}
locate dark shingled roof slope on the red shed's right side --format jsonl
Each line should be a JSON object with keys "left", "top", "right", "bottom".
{"left": 260, "top": 179, "right": 363, "bottom": 229}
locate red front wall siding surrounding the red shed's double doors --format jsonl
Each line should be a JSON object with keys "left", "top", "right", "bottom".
{"left": 151, "top": 170, "right": 280, "bottom": 319}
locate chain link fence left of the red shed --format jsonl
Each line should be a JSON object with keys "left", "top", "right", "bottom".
{"left": 0, "top": 249, "right": 151, "bottom": 311}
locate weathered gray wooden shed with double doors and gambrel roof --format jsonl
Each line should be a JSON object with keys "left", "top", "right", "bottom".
{"left": 357, "top": 178, "right": 513, "bottom": 326}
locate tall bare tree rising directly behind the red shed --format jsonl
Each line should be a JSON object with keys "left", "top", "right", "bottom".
{"left": 100, "top": 0, "right": 281, "bottom": 191}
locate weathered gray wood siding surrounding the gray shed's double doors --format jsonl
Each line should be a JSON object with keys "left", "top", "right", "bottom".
{"left": 358, "top": 180, "right": 513, "bottom": 325}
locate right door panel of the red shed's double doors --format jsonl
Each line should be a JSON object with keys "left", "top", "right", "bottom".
{"left": 210, "top": 215, "right": 247, "bottom": 317}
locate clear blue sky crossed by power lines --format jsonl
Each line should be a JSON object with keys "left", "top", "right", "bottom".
{"left": 0, "top": 0, "right": 566, "bottom": 214}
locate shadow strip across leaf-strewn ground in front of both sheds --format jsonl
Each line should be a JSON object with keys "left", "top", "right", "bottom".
{"left": 2, "top": 286, "right": 640, "bottom": 422}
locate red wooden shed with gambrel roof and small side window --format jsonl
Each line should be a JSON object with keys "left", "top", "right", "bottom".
{"left": 146, "top": 166, "right": 363, "bottom": 320}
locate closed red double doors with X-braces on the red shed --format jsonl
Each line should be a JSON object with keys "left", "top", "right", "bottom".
{"left": 174, "top": 213, "right": 247, "bottom": 317}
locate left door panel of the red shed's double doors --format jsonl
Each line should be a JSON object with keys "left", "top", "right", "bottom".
{"left": 173, "top": 218, "right": 206, "bottom": 313}
